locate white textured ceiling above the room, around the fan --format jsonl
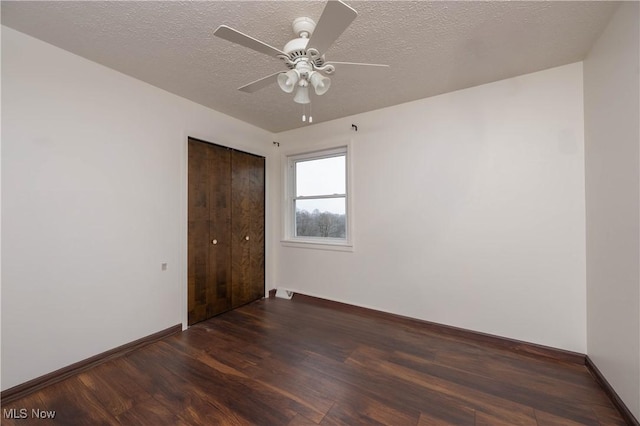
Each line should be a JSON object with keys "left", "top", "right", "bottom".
{"left": 2, "top": 0, "right": 618, "bottom": 132}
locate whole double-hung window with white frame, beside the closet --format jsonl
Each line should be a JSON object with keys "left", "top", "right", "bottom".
{"left": 285, "top": 146, "right": 350, "bottom": 246}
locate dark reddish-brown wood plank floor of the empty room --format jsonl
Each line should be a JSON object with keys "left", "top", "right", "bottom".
{"left": 2, "top": 297, "right": 624, "bottom": 426}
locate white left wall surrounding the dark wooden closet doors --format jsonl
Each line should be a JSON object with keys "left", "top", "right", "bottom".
{"left": 2, "top": 27, "right": 278, "bottom": 389}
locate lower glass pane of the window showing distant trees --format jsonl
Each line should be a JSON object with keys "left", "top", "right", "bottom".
{"left": 295, "top": 198, "right": 347, "bottom": 238}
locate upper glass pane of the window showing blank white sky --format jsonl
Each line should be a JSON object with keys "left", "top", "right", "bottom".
{"left": 296, "top": 155, "right": 346, "bottom": 197}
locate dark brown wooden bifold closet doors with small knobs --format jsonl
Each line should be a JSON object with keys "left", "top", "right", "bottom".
{"left": 188, "top": 139, "right": 265, "bottom": 325}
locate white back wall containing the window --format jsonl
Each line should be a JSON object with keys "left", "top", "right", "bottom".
{"left": 274, "top": 63, "right": 586, "bottom": 353}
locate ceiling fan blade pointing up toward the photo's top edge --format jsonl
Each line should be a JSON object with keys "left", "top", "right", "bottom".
{"left": 307, "top": 0, "right": 358, "bottom": 55}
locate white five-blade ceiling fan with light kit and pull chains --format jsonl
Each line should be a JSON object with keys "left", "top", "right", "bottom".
{"left": 214, "top": 0, "right": 388, "bottom": 113}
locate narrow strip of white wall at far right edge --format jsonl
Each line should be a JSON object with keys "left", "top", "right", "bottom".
{"left": 584, "top": 2, "right": 640, "bottom": 419}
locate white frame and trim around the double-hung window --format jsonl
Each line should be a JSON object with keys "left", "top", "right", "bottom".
{"left": 281, "top": 142, "right": 353, "bottom": 251}
